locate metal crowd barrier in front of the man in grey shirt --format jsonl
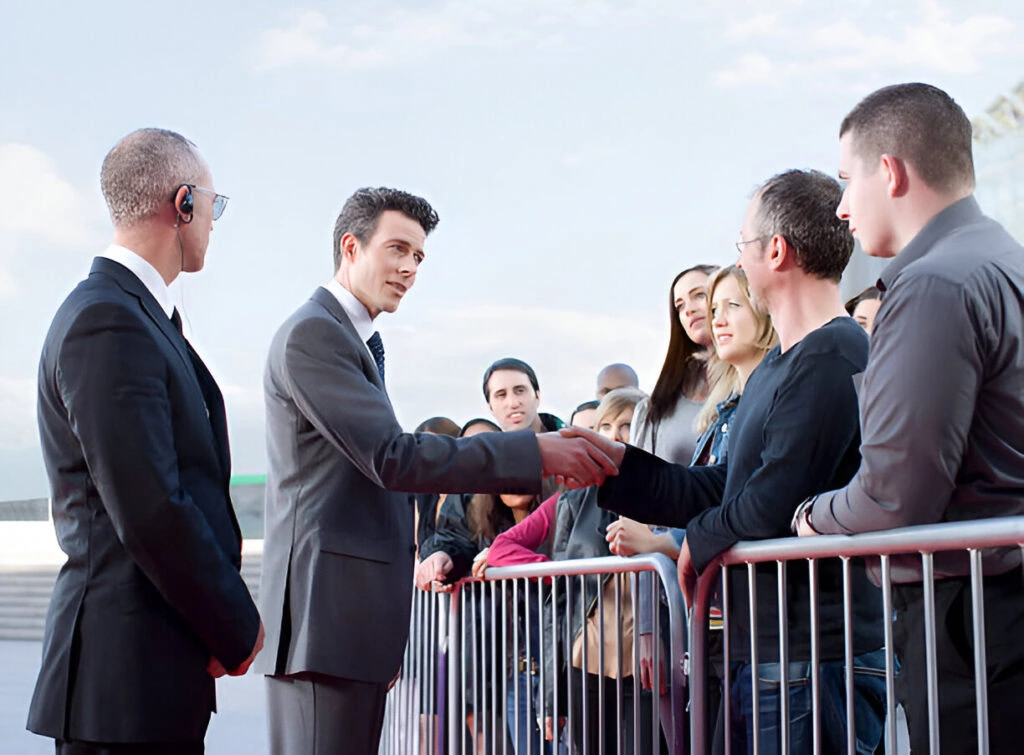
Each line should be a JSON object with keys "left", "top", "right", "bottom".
{"left": 688, "top": 516, "right": 1024, "bottom": 754}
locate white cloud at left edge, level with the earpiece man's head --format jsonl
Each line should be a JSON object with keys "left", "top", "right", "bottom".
{"left": 0, "top": 143, "right": 99, "bottom": 300}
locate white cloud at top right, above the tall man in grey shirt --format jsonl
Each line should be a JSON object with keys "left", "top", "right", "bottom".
{"left": 714, "top": 0, "right": 1017, "bottom": 88}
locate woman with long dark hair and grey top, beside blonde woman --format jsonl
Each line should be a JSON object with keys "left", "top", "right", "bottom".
{"left": 633, "top": 264, "right": 716, "bottom": 464}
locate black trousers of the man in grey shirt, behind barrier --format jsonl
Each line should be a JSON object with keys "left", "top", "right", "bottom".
{"left": 893, "top": 568, "right": 1024, "bottom": 753}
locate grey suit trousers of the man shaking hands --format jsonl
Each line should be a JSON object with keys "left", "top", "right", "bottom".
{"left": 266, "top": 673, "right": 387, "bottom": 755}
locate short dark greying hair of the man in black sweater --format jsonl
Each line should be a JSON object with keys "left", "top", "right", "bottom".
{"left": 757, "top": 170, "right": 853, "bottom": 282}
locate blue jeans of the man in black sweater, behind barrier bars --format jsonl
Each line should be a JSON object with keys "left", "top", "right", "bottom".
{"left": 731, "top": 651, "right": 886, "bottom": 755}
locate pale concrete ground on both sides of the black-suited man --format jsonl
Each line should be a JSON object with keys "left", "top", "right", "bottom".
{"left": 0, "top": 641, "right": 267, "bottom": 755}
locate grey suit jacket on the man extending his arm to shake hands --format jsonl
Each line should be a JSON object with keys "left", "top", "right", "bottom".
{"left": 254, "top": 288, "right": 541, "bottom": 682}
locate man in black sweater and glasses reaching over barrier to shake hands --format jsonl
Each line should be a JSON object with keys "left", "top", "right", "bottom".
{"left": 585, "top": 171, "right": 885, "bottom": 752}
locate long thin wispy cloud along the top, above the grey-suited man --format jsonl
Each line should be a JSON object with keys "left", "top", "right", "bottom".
{"left": 249, "top": 0, "right": 677, "bottom": 71}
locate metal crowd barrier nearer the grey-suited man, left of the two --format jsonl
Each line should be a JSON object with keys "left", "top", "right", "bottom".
{"left": 380, "top": 554, "right": 688, "bottom": 755}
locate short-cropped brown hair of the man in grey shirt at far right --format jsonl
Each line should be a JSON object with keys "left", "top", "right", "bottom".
{"left": 839, "top": 84, "right": 975, "bottom": 192}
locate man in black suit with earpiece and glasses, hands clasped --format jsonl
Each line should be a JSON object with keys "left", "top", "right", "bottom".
{"left": 29, "top": 129, "right": 263, "bottom": 755}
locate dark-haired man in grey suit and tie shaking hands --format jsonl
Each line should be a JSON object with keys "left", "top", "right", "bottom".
{"left": 260, "top": 188, "right": 616, "bottom": 755}
